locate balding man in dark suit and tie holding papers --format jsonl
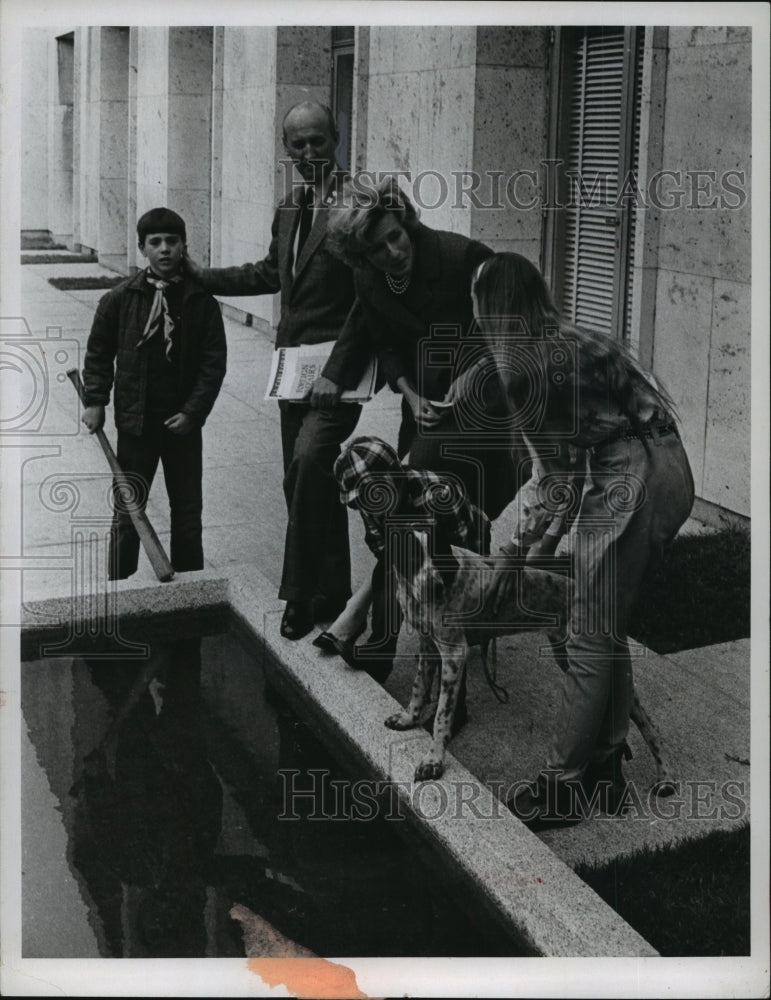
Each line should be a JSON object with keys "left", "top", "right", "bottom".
{"left": 193, "top": 101, "right": 361, "bottom": 639}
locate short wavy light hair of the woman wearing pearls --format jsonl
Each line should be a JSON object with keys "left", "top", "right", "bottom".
{"left": 326, "top": 175, "right": 418, "bottom": 267}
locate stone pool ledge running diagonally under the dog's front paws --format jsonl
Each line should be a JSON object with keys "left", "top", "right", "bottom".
{"left": 223, "top": 571, "right": 658, "bottom": 957}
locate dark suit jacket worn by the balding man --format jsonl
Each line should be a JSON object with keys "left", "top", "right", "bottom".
{"left": 200, "top": 171, "right": 355, "bottom": 347}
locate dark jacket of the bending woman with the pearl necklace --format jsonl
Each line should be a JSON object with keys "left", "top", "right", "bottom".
{"left": 324, "top": 224, "right": 493, "bottom": 399}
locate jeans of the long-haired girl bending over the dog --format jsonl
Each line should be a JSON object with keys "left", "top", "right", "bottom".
{"left": 548, "top": 433, "right": 694, "bottom": 780}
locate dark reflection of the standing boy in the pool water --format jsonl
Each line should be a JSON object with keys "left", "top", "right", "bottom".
{"left": 70, "top": 639, "right": 222, "bottom": 958}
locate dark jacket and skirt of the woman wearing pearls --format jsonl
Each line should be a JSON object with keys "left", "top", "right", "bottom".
{"left": 324, "top": 224, "right": 529, "bottom": 517}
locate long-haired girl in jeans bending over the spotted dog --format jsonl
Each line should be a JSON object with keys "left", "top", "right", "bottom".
{"left": 472, "top": 253, "right": 694, "bottom": 829}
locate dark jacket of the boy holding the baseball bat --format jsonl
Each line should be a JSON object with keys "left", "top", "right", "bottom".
{"left": 83, "top": 271, "right": 227, "bottom": 434}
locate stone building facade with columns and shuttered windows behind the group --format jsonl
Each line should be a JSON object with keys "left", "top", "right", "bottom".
{"left": 22, "top": 25, "right": 752, "bottom": 519}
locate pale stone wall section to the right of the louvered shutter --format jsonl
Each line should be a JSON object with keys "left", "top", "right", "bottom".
{"left": 653, "top": 28, "right": 752, "bottom": 514}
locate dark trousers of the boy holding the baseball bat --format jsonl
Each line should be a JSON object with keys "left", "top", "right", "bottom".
{"left": 109, "top": 418, "right": 203, "bottom": 580}
